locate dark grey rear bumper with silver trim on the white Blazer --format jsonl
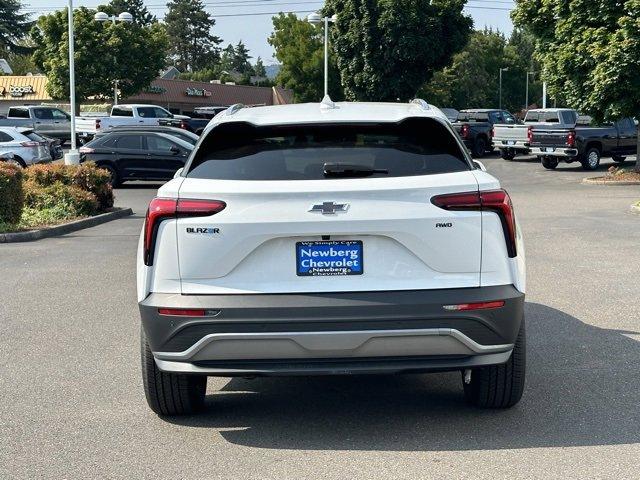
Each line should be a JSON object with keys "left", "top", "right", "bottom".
{"left": 140, "top": 285, "right": 524, "bottom": 376}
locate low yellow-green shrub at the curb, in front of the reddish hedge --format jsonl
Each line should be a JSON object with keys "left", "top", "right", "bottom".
{"left": 23, "top": 180, "right": 99, "bottom": 218}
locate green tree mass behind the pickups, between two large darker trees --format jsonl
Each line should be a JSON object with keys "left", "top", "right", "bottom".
{"left": 418, "top": 29, "right": 541, "bottom": 112}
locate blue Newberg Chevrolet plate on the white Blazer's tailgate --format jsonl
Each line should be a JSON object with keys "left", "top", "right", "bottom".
{"left": 296, "top": 240, "right": 364, "bottom": 277}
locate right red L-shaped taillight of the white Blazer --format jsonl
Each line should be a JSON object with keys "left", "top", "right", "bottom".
{"left": 431, "top": 189, "right": 517, "bottom": 257}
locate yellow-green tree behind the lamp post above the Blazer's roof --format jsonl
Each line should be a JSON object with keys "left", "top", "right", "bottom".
{"left": 268, "top": 13, "right": 344, "bottom": 102}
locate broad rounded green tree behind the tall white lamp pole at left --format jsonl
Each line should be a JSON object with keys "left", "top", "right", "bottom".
{"left": 31, "top": 7, "right": 168, "bottom": 106}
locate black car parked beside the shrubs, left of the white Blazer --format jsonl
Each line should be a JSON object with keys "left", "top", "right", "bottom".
{"left": 80, "top": 131, "right": 193, "bottom": 187}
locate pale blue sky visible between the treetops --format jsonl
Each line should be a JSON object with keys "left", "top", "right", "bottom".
{"left": 23, "top": 0, "right": 514, "bottom": 65}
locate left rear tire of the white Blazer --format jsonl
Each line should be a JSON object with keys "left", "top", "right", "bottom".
{"left": 140, "top": 329, "right": 207, "bottom": 416}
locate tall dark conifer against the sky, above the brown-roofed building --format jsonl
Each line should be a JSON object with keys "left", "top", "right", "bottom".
{"left": 164, "top": 0, "right": 222, "bottom": 72}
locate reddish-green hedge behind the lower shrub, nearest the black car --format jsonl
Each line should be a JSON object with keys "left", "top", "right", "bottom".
{"left": 25, "top": 163, "right": 113, "bottom": 211}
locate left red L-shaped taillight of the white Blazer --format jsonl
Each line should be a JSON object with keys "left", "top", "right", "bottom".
{"left": 144, "top": 198, "right": 227, "bottom": 266}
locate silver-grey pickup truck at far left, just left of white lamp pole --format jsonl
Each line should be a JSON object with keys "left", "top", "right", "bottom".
{"left": 0, "top": 105, "right": 71, "bottom": 143}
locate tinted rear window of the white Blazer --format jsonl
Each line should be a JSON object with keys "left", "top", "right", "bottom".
{"left": 187, "top": 118, "right": 471, "bottom": 180}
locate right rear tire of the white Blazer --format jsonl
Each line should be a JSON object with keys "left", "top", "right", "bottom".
{"left": 462, "top": 319, "right": 527, "bottom": 408}
